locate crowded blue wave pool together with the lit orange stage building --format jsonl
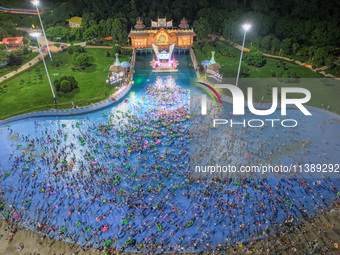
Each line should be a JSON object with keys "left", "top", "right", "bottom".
{"left": 0, "top": 8, "right": 340, "bottom": 254}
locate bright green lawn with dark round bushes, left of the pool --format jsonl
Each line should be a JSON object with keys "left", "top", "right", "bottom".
{"left": 0, "top": 49, "right": 130, "bottom": 119}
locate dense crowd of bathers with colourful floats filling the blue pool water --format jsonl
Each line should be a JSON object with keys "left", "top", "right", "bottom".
{"left": 0, "top": 76, "right": 340, "bottom": 254}
